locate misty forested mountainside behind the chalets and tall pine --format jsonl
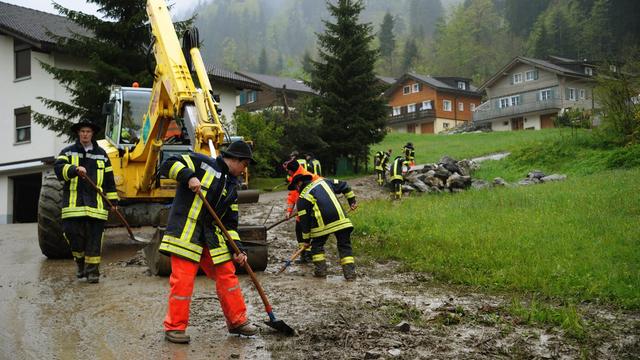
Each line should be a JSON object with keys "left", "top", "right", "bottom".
{"left": 190, "top": 0, "right": 640, "bottom": 85}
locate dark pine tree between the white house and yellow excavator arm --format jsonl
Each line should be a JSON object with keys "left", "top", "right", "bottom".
{"left": 33, "top": 0, "right": 152, "bottom": 135}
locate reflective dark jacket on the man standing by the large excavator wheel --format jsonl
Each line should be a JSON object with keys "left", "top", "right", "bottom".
{"left": 53, "top": 141, "right": 118, "bottom": 220}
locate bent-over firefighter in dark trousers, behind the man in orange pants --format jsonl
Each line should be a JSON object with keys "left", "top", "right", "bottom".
{"left": 292, "top": 174, "right": 357, "bottom": 281}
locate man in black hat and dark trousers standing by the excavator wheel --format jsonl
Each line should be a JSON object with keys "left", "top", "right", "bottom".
{"left": 53, "top": 119, "right": 118, "bottom": 284}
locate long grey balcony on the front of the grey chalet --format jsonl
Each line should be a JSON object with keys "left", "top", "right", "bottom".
{"left": 473, "top": 97, "right": 563, "bottom": 122}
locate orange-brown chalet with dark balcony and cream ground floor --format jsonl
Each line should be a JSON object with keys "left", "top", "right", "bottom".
{"left": 385, "top": 73, "right": 481, "bottom": 134}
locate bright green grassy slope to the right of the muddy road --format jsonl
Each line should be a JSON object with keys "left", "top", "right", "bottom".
{"left": 352, "top": 130, "right": 640, "bottom": 309}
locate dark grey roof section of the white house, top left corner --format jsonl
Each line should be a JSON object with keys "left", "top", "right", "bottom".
{"left": 0, "top": 2, "right": 88, "bottom": 50}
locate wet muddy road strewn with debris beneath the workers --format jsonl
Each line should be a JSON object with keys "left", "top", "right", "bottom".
{"left": 0, "top": 177, "right": 640, "bottom": 359}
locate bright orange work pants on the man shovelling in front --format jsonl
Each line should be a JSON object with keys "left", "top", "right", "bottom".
{"left": 164, "top": 247, "right": 247, "bottom": 331}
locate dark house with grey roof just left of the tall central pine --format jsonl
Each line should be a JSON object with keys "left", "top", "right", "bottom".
{"left": 236, "top": 71, "right": 316, "bottom": 112}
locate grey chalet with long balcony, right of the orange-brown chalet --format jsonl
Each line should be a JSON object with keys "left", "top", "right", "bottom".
{"left": 473, "top": 56, "right": 597, "bottom": 131}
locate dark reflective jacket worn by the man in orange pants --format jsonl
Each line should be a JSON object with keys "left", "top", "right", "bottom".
{"left": 159, "top": 153, "right": 241, "bottom": 264}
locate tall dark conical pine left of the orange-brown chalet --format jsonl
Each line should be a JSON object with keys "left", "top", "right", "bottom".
{"left": 310, "top": 0, "right": 386, "bottom": 171}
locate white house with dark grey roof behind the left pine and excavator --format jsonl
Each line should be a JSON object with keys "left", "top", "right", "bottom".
{"left": 0, "top": 2, "right": 260, "bottom": 224}
